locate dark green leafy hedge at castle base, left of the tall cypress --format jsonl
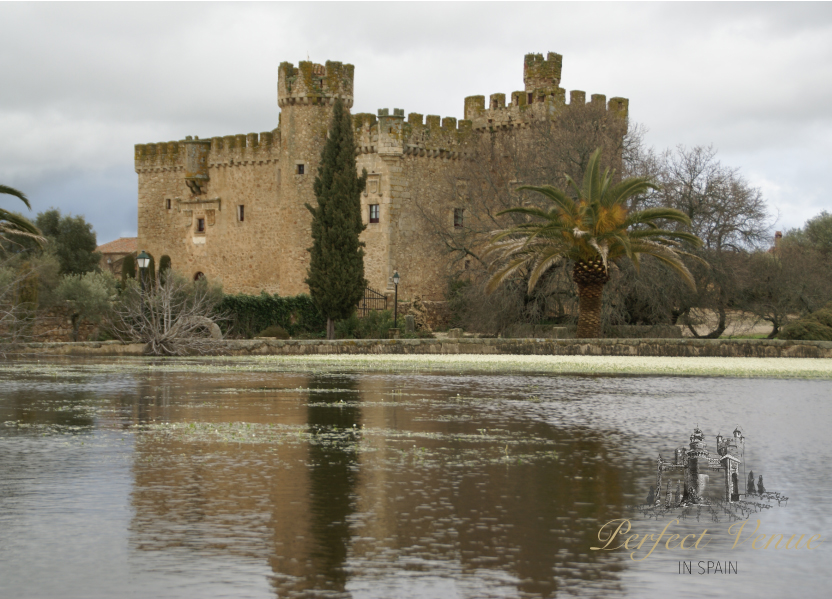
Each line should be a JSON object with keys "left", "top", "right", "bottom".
{"left": 217, "top": 291, "right": 326, "bottom": 338}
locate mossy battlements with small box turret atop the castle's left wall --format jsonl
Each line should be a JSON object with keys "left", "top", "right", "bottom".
{"left": 135, "top": 130, "right": 280, "bottom": 171}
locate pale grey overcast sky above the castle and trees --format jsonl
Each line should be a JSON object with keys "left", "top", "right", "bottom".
{"left": 0, "top": 2, "right": 832, "bottom": 243}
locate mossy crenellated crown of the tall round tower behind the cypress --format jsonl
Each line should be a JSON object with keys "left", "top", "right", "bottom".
{"left": 277, "top": 60, "right": 355, "bottom": 108}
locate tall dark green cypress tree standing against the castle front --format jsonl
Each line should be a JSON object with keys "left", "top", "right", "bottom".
{"left": 306, "top": 99, "right": 367, "bottom": 339}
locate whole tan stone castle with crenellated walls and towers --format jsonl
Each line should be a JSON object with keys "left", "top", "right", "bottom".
{"left": 135, "top": 52, "right": 628, "bottom": 299}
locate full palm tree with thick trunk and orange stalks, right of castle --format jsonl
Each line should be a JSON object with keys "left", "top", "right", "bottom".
{"left": 487, "top": 149, "right": 702, "bottom": 338}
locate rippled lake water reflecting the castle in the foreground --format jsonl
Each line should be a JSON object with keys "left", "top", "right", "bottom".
{"left": 0, "top": 359, "right": 832, "bottom": 598}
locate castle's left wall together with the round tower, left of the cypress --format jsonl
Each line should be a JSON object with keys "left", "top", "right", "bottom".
{"left": 135, "top": 62, "right": 354, "bottom": 295}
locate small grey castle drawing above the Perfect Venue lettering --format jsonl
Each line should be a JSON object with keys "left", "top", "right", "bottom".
{"left": 648, "top": 427, "right": 748, "bottom": 507}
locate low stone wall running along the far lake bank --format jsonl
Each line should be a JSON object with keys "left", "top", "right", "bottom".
{"left": 13, "top": 339, "right": 832, "bottom": 358}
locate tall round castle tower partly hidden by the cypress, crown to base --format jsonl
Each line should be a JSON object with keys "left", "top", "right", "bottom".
{"left": 274, "top": 61, "right": 354, "bottom": 295}
